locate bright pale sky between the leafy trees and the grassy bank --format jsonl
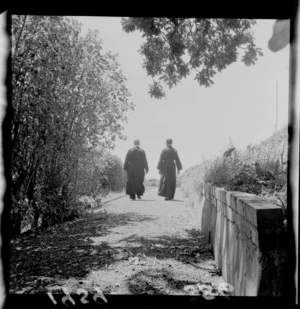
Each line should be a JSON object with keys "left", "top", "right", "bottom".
{"left": 77, "top": 17, "right": 289, "bottom": 178}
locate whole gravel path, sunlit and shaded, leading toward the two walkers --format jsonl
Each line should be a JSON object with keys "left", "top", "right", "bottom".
{"left": 10, "top": 189, "right": 224, "bottom": 295}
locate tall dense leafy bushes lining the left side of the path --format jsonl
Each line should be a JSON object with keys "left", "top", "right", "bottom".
{"left": 11, "top": 15, "right": 134, "bottom": 233}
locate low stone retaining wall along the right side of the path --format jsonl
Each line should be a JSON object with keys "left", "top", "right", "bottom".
{"left": 192, "top": 184, "right": 286, "bottom": 296}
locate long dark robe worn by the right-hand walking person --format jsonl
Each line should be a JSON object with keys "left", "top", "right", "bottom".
{"left": 157, "top": 146, "right": 182, "bottom": 199}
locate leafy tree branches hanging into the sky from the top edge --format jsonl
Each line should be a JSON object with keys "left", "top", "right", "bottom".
{"left": 121, "top": 17, "right": 263, "bottom": 98}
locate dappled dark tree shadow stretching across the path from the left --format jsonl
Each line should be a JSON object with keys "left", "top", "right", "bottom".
{"left": 10, "top": 195, "right": 216, "bottom": 293}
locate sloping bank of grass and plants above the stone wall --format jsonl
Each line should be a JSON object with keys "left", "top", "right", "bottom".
{"left": 180, "top": 127, "right": 288, "bottom": 224}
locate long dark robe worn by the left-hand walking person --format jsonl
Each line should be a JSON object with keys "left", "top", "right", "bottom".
{"left": 124, "top": 146, "right": 149, "bottom": 199}
